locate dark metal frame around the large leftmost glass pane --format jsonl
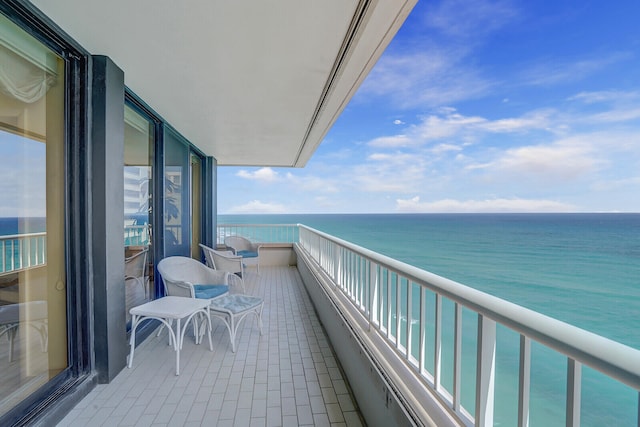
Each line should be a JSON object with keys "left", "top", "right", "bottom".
{"left": 0, "top": 0, "right": 95, "bottom": 425}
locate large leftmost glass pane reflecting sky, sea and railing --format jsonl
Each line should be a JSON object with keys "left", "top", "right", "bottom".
{"left": 0, "top": 15, "right": 68, "bottom": 415}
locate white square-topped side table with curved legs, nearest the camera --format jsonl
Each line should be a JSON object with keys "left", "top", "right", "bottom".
{"left": 127, "top": 296, "right": 213, "bottom": 375}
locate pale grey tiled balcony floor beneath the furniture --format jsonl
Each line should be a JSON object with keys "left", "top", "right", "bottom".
{"left": 59, "top": 267, "right": 363, "bottom": 427}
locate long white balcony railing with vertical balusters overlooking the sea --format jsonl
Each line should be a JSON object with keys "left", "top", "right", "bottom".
{"left": 218, "top": 224, "right": 640, "bottom": 426}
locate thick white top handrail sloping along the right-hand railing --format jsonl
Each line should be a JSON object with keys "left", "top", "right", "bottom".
{"left": 298, "top": 224, "right": 640, "bottom": 391}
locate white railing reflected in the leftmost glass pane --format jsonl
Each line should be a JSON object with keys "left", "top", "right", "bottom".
{"left": 0, "top": 233, "right": 47, "bottom": 274}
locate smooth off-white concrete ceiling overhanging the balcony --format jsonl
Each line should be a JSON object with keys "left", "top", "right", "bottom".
{"left": 32, "top": 0, "right": 417, "bottom": 167}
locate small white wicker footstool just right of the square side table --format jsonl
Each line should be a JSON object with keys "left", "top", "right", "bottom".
{"left": 209, "top": 294, "right": 264, "bottom": 353}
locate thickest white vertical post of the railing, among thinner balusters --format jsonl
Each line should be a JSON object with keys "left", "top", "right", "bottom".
{"left": 475, "top": 314, "right": 496, "bottom": 427}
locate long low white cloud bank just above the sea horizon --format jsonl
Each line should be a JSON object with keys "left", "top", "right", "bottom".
{"left": 396, "top": 196, "right": 576, "bottom": 213}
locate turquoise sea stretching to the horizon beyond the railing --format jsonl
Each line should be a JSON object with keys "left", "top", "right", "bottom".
{"left": 219, "top": 214, "right": 640, "bottom": 426}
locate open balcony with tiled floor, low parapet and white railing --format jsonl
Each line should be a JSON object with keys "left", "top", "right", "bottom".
{"left": 62, "top": 224, "right": 640, "bottom": 426}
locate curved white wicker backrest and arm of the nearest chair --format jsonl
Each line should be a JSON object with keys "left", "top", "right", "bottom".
{"left": 158, "top": 256, "right": 229, "bottom": 298}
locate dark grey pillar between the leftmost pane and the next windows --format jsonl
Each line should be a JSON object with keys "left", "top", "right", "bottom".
{"left": 91, "top": 56, "right": 129, "bottom": 383}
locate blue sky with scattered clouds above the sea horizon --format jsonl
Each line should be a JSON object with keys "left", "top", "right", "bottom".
{"left": 224, "top": 0, "right": 640, "bottom": 214}
